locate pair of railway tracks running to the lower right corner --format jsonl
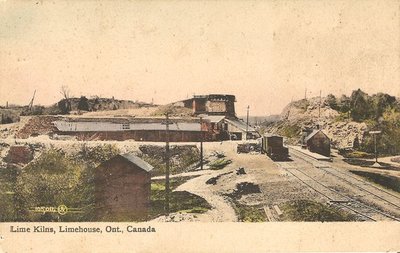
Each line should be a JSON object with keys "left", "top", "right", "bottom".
{"left": 280, "top": 148, "right": 400, "bottom": 221}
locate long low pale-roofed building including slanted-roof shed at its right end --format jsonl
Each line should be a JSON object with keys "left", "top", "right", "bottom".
{"left": 53, "top": 116, "right": 259, "bottom": 142}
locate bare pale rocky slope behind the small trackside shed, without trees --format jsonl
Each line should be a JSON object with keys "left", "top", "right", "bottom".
{"left": 266, "top": 97, "right": 367, "bottom": 148}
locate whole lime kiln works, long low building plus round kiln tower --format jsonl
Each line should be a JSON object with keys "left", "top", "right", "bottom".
{"left": 49, "top": 94, "right": 260, "bottom": 142}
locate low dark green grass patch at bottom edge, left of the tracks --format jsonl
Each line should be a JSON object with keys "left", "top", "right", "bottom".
{"left": 281, "top": 200, "right": 356, "bottom": 221}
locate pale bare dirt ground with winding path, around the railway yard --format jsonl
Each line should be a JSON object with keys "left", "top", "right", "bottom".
{"left": 0, "top": 134, "right": 400, "bottom": 222}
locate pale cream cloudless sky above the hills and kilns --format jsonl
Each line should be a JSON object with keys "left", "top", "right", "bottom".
{"left": 0, "top": 0, "right": 400, "bottom": 116}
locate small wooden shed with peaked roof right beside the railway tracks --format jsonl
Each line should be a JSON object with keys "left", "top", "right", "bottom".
{"left": 304, "top": 129, "right": 331, "bottom": 157}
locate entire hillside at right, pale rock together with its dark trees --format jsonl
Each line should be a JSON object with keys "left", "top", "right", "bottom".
{"left": 264, "top": 90, "right": 400, "bottom": 154}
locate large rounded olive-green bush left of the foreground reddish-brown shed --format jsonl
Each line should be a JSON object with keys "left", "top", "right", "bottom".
{"left": 14, "top": 150, "right": 94, "bottom": 221}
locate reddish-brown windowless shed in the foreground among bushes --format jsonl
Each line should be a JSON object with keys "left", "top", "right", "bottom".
{"left": 95, "top": 153, "right": 153, "bottom": 221}
